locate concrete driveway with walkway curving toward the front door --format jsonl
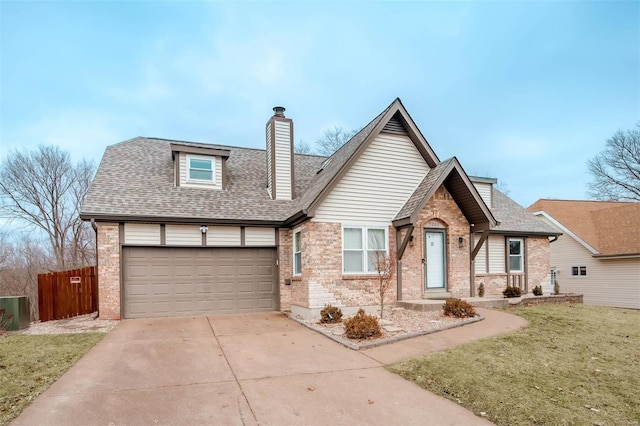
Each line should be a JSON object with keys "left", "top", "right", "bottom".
{"left": 13, "top": 310, "right": 526, "bottom": 426}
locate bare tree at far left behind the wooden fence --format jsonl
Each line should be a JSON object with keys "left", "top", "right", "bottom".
{"left": 0, "top": 146, "right": 95, "bottom": 270}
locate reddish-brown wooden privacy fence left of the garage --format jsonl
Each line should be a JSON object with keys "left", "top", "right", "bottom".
{"left": 38, "top": 266, "right": 98, "bottom": 321}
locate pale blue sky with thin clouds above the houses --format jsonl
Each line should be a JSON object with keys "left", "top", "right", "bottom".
{"left": 0, "top": 0, "right": 640, "bottom": 207}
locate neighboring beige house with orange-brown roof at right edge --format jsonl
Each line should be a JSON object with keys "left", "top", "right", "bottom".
{"left": 528, "top": 199, "right": 640, "bottom": 309}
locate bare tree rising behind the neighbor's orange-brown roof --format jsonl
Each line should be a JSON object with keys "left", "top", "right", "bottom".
{"left": 587, "top": 122, "right": 640, "bottom": 201}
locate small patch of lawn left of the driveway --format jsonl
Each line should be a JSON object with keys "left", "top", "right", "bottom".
{"left": 0, "top": 333, "right": 105, "bottom": 425}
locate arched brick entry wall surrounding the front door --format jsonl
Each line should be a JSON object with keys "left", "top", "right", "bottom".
{"left": 402, "top": 186, "right": 470, "bottom": 300}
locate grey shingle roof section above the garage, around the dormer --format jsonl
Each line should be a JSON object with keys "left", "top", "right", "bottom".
{"left": 82, "top": 137, "right": 325, "bottom": 222}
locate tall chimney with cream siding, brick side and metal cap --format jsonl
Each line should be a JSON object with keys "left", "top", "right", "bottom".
{"left": 266, "top": 106, "right": 295, "bottom": 200}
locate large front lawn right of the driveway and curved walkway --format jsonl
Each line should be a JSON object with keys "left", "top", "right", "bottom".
{"left": 389, "top": 305, "right": 640, "bottom": 425}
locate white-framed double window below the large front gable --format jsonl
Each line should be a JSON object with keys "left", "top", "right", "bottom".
{"left": 342, "top": 226, "right": 387, "bottom": 274}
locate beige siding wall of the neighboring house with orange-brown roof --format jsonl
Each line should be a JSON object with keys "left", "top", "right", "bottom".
{"left": 542, "top": 218, "right": 640, "bottom": 309}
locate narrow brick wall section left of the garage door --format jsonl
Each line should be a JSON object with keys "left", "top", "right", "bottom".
{"left": 96, "top": 223, "right": 120, "bottom": 319}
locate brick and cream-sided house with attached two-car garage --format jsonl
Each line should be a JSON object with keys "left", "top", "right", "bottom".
{"left": 81, "top": 99, "right": 558, "bottom": 318}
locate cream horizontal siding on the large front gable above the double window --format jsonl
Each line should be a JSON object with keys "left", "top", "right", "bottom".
{"left": 312, "top": 134, "right": 429, "bottom": 223}
